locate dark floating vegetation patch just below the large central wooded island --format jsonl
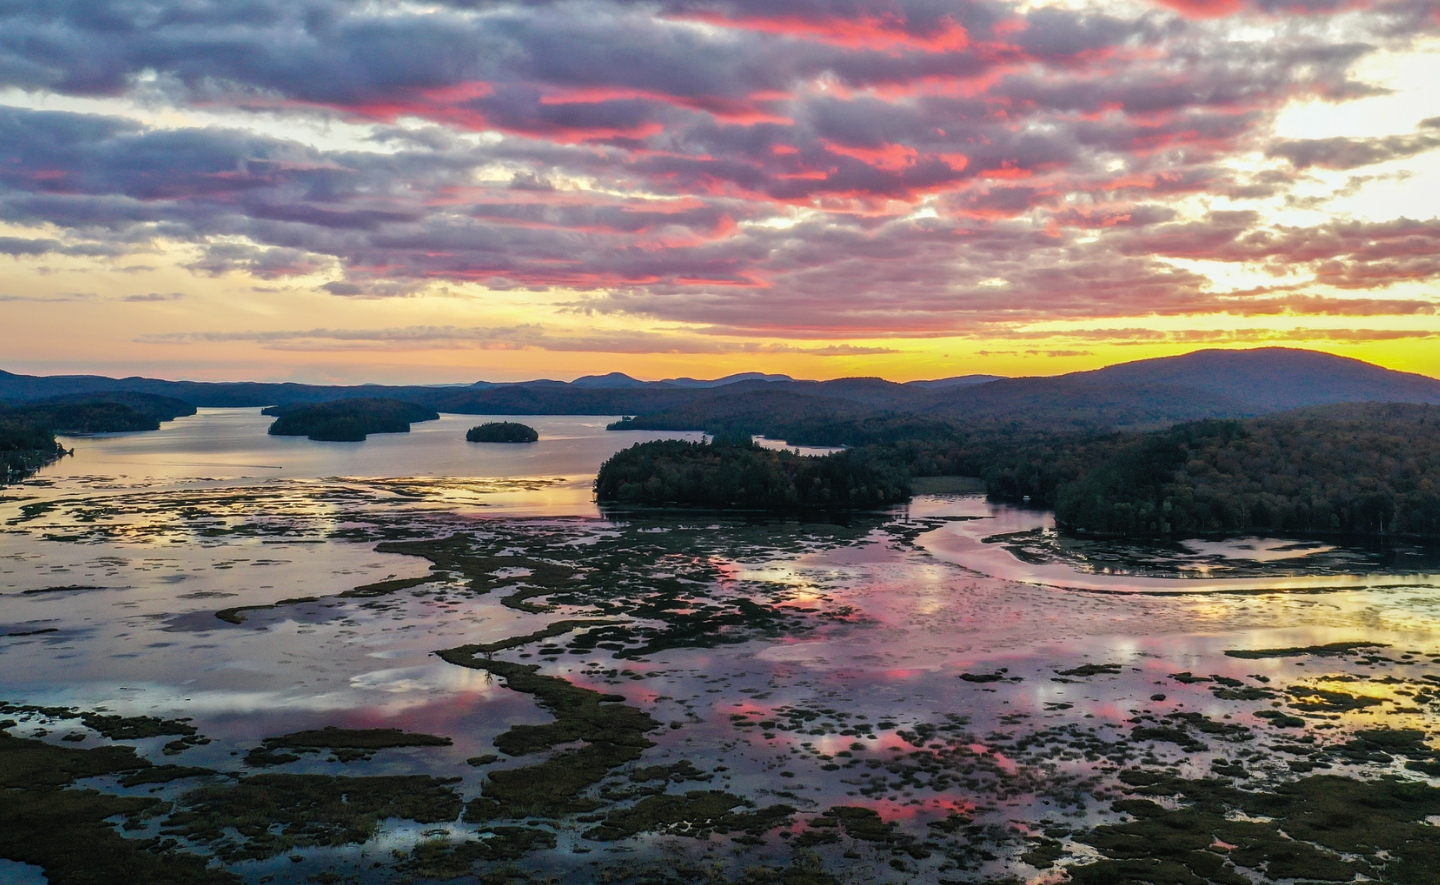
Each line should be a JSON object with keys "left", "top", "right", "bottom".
{"left": 365, "top": 519, "right": 884, "bottom": 659}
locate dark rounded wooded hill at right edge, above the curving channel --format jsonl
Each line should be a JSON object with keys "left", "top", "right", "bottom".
{"left": 1056, "top": 403, "right": 1440, "bottom": 537}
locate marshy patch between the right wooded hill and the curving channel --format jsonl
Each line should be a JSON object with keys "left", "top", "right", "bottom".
{"left": 985, "top": 528, "right": 1440, "bottom": 580}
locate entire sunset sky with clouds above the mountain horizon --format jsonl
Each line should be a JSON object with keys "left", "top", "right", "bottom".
{"left": 0, "top": 0, "right": 1440, "bottom": 383}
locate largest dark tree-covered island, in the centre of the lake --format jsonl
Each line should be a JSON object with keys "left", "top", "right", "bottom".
{"left": 595, "top": 437, "right": 910, "bottom": 511}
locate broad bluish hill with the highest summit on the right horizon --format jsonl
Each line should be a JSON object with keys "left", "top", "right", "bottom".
{"left": 615, "top": 348, "right": 1440, "bottom": 445}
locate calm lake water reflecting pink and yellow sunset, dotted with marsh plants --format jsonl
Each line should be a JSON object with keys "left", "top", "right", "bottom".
{"left": 0, "top": 409, "right": 1440, "bottom": 882}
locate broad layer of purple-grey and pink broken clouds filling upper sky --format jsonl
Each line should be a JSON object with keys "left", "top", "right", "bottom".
{"left": 0, "top": 0, "right": 1440, "bottom": 342}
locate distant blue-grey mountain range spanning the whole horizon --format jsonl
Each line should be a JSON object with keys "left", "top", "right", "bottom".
{"left": 0, "top": 348, "right": 1440, "bottom": 429}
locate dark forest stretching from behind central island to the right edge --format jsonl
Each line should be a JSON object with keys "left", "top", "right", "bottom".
{"left": 613, "top": 403, "right": 1440, "bottom": 537}
